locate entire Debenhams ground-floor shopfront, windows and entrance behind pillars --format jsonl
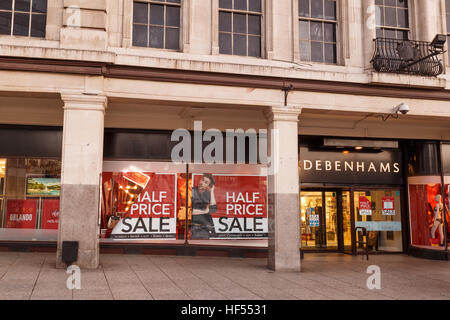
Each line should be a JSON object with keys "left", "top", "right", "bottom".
{"left": 0, "top": 126, "right": 450, "bottom": 259}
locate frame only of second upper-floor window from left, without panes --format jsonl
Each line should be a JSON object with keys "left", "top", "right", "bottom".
{"left": 130, "top": 0, "right": 186, "bottom": 52}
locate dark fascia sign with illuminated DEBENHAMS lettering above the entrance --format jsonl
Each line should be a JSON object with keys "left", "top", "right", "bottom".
{"left": 300, "top": 147, "right": 402, "bottom": 185}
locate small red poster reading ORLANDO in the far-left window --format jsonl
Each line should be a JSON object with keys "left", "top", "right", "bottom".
{"left": 5, "top": 200, "right": 37, "bottom": 229}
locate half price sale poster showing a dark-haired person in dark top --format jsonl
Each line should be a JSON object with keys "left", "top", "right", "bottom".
{"left": 191, "top": 174, "right": 268, "bottom": 239}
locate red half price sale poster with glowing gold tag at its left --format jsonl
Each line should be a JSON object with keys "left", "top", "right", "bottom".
{"left": 107, "top": 172, "right": 177, "bottom": 239}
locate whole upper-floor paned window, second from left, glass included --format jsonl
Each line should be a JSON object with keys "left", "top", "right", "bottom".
{"left": 133, "top": 0, "right": 181, "bottom": 50}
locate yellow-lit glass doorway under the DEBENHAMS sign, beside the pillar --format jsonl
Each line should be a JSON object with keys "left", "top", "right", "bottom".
{"left": 300, "top": 190, "right": 352, "bottom": 253}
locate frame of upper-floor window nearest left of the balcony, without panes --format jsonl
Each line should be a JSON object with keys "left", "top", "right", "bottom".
{"left": 293, "top": 0, "right": 346, "bottom": 66}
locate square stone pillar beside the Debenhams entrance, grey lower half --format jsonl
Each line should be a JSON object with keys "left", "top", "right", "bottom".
{"left": 267, "top": 107, "right": 301, "bottom": 271}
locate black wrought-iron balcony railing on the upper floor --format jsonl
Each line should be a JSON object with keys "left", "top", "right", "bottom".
{"left": 371, "top": 35, "right": 445, "bottom": 77}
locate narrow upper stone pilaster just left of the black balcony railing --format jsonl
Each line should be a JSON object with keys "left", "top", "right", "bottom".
{"left": 362, "top": 0, "right": 377, "bottom": 70}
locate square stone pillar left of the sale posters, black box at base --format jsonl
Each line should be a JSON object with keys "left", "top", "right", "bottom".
{"left": 56, "top": 94, "right": 107, "bottom": 269}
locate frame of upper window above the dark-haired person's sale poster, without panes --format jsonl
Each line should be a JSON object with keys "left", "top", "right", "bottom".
{"left": 217, "top": 0, "right": 271, "bottom": 59}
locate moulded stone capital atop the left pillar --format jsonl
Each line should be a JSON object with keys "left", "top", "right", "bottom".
{"left": 61, "top": 92, "right": 108, "bottom": 112}
